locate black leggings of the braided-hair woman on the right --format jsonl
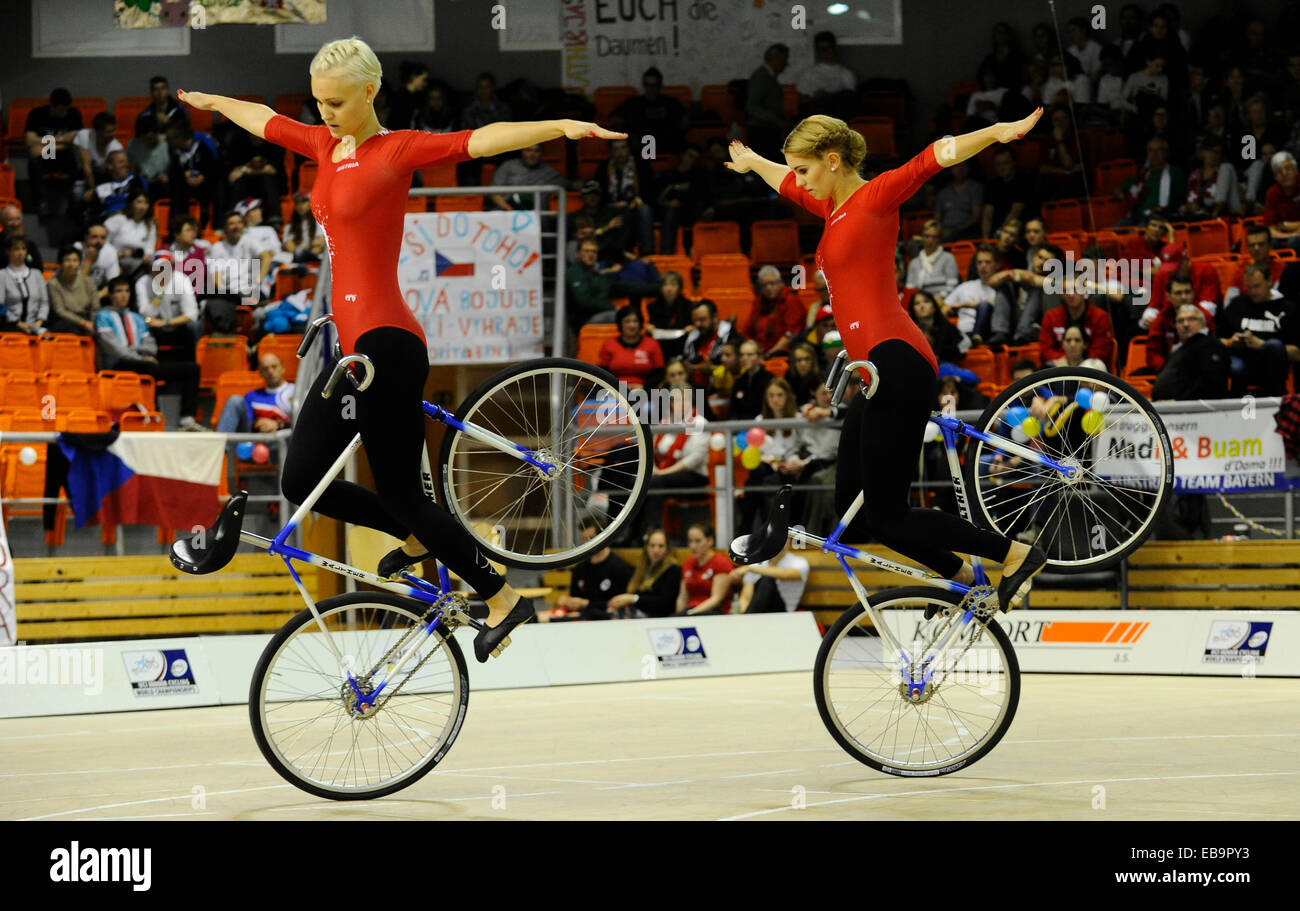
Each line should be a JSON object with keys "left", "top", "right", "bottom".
{"left": 835, "top": 339, "right": 1011, "bottom": 578}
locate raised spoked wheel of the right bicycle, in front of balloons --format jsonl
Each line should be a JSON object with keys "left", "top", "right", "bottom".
{"left": 963, "top": 366, "right": 1174, "bottom": 573}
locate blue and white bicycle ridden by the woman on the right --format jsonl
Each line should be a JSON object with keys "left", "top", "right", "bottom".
{"left": 731, "top": 352, "right": 1174, "bottom": 776}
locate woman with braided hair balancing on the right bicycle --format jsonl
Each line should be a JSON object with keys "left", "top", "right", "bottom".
{"left": 725, "top": 108, "right": 1047, "bottom": 609}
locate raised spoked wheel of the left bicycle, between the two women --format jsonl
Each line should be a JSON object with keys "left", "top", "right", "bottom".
{"left": 438, "top": 357, "right": 653, "bottom": 569}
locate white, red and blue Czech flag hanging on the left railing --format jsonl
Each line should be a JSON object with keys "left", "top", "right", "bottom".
{"left": 59, "top": 431, "right": 226, "bottom": 529}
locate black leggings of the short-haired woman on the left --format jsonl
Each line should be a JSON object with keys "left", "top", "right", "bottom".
{"left": 283, "top": 326, "right": 506, "bottom": 598}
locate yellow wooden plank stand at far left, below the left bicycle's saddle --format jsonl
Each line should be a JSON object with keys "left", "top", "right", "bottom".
{"left": 14, "top": 554, "right": 317, "bottom": 642}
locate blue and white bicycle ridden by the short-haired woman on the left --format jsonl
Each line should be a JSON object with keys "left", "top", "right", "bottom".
{"left": 170, "top": 317, "right": 651, "bottom": 801}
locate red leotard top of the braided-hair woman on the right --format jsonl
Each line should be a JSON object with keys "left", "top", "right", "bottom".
{"left": 781, "top": 146, "right": 941, "bottom": 374}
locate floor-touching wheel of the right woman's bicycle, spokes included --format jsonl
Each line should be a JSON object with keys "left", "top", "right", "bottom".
{"left": 813, "top": 586, "right": 1021, "bottom": 777}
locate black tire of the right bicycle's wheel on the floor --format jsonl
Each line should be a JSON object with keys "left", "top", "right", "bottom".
{"left": 813, "top": 586, "right": 1021, "bottom": 777}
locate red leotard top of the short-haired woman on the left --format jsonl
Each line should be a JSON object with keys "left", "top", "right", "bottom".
{"left": 265, "top": 114, "right": 472, "bottom": 353}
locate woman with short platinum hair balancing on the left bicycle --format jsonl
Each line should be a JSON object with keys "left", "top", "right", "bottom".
{"left": 177, "top": 38, "right": 627, "bottom": 661}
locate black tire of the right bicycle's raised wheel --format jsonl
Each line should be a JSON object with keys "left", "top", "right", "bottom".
{"left": 962, "top": 366, "right": 1174, "bottom": 574}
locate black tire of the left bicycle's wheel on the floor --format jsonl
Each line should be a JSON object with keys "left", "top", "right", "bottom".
{"left": 248, "top": 591, "right": 469, "bottom": 801}
